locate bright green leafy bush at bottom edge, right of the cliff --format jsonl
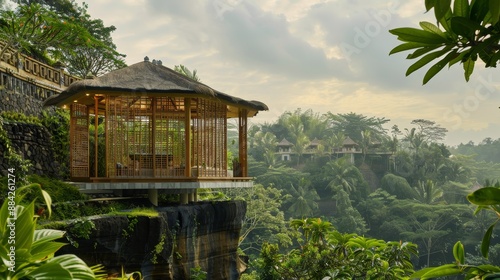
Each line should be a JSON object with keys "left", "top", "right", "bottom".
{"left": 257, "top": 218, "right": 417, "bottom": 279}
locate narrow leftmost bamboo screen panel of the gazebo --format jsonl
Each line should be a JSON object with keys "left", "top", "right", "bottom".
{"left": 70, "top": 103, "right": 89, "bottom": 178}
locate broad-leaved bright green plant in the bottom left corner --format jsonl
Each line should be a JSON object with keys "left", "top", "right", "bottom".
{"left": 0, "top": 185, "right": 100, "bottom": 280}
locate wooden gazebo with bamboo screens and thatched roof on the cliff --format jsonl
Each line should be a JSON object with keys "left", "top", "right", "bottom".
{"left": 45, "top": 60, "right": 268, "bottom": 203}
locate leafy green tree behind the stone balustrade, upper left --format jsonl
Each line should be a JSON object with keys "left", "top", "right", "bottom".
{"left": 0, "top": 0, "right": 125, "bottom": 77}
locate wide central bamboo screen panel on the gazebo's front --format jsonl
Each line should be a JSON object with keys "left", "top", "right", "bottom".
{"left": 106, "top": 96, "right": 186, "bottom": 178}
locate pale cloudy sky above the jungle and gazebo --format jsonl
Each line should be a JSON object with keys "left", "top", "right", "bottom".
{"left": 78, "top": 0, "right": 500, "bottom": 146}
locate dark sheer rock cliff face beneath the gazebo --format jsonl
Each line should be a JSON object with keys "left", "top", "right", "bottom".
{"left": 58, "top": 201, "right": 246, "bottom": 280}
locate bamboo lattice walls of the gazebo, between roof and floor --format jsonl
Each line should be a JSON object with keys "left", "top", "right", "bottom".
{"left": 71, "top": 95, "right": 228, "bottom": 179}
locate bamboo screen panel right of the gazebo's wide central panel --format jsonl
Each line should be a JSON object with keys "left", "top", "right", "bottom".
{"left": 192, "top": 98, "right": 227, "bottom": 177}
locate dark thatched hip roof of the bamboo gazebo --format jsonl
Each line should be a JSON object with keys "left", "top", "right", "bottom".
{"left": 44, "top": 61, "right": 268, "bottom": 114}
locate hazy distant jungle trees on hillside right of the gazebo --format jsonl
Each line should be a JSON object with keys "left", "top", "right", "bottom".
{"left": 242, "top": 106, "right": 500, "bottom": 268}
